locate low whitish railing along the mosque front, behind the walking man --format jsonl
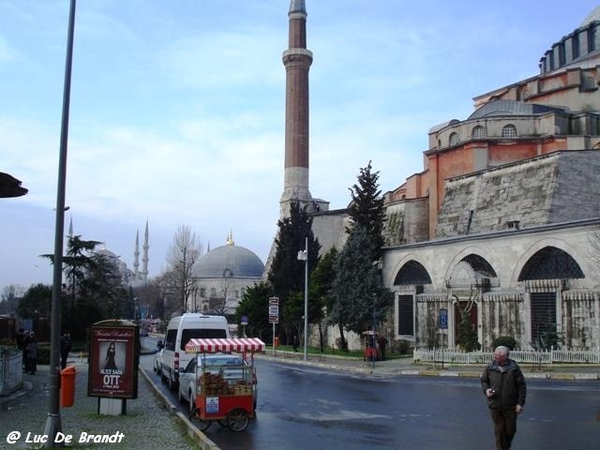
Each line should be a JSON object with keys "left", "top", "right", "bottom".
{"left": 413, "top": 348, "right": 600, "bottom": 364}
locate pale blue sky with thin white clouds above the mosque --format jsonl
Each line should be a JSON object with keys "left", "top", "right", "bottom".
{"left": 0, "top": 0, "right": 600, "bottom": 293}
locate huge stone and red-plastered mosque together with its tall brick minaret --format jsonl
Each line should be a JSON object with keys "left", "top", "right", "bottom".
{"left": 280, "top": 0, "right": 600, "bottom": 348}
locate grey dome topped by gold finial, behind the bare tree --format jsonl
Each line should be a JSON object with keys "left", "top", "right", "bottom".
{"left": 194, "top": 237, "right": 265, "bottom": 278}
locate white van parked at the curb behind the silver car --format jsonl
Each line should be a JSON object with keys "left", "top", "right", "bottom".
{"left": 158, "top": 313, "right": 231, "bottom": 390}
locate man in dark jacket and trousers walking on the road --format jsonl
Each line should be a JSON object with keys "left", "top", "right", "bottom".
{"left": 481, "top": 346, "right": 527, "bottom": 450}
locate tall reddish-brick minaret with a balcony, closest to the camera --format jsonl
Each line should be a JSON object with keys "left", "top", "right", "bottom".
{"left": 279, "top": 0, "right": 313, "bottom": 217}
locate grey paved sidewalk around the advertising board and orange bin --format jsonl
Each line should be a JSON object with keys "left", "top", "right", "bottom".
{"left": 0, "top": 358, "right": 218, "bottom": 450}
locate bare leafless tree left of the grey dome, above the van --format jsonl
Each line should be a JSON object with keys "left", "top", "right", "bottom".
{"left": 167, "top": 225, "right": 202, "bottom": 312}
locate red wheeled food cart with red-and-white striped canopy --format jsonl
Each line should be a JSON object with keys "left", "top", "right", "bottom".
{"left": 185, "top": 338, "right": 265, "bottom": 431}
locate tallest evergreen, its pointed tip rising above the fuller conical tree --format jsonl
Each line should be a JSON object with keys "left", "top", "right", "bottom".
{"left": 346, "top": 161, "right": 386, "bottom": 261}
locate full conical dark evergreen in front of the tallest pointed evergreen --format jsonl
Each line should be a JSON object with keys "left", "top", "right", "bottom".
{"left": 329, "top": 224, "right": 394, "bottom": 340}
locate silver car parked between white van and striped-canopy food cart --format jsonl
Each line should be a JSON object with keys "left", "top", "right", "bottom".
{"left": 177, "top": 353, "right": 258, "bottom": 411}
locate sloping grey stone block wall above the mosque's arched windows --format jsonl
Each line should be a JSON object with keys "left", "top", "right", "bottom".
{"left": 436, "top": 150, "right": 600, "bottom": 238}
